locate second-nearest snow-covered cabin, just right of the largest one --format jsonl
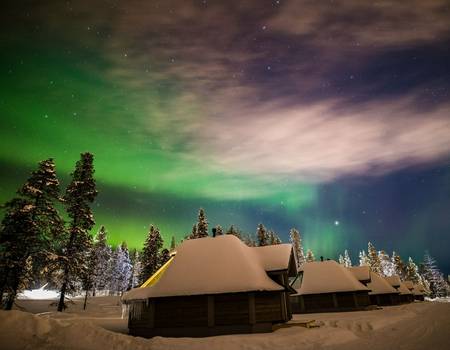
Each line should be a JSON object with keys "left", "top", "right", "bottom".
{"left": 291, "top": 260, "right": 370, "bottom": 313}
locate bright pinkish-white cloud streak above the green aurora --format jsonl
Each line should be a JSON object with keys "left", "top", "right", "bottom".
{"left": 199, "top": 99, "right": 450, "bottom": 182}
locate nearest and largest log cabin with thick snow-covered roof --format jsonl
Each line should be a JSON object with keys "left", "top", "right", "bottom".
{"left": 122, "top": 235, "right": 296, "bottom": 337}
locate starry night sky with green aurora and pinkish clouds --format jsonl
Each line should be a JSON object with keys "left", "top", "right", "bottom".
{"left": 0, "top": 0, "right": 450, "bottom": 272}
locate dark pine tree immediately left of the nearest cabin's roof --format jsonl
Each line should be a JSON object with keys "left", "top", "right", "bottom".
{"left": 140, "top": 225, "right": 163, "bottom": 283}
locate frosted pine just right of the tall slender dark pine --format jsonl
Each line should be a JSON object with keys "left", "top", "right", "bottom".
{"left": 92, "top": 226, "right": 112, "bottom": 296}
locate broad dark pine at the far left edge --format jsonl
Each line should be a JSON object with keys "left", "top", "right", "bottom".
{"left": 0, "top": 158, "right": 63, "bottom": 309}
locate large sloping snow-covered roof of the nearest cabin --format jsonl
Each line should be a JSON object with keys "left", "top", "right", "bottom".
{"left": 122, "top": 235, "right": 290, "bottom": 301}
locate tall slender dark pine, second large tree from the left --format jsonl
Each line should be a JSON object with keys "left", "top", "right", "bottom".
{"left": 58, "top": 153, "right": 97, "bottom": 311}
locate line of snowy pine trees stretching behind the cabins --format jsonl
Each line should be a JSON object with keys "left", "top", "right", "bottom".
{"left": 0, "top": 156, "right": 448, "bottom": 311}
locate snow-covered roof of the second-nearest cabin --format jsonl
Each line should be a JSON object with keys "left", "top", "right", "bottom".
{"left": 294, "top": 260, "right": 368, "bottom": 295}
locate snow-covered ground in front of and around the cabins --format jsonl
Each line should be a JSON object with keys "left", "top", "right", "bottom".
{"left": 0, "top": 297, "right": 450, "bottom": 350}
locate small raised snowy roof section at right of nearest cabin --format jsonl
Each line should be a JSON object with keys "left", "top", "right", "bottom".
{"left": 252, "top": 244, "right": 292, "bottom": 271}
